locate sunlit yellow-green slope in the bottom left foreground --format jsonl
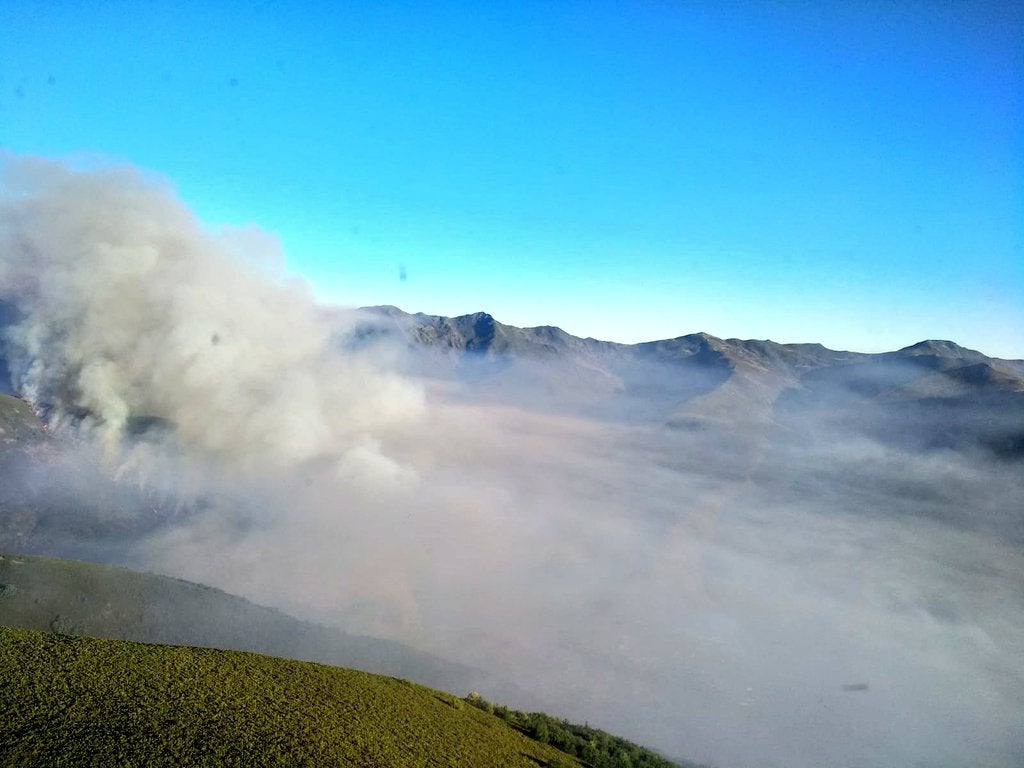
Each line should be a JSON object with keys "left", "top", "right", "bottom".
{"left": 0, "top": 627, "right": 579, "bottom": 768}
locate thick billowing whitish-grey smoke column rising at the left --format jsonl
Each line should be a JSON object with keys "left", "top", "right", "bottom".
{"left": 0, "top": 156, "right": 422, "bottom": 475}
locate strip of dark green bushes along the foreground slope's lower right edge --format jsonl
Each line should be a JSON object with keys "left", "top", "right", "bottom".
{"left": 466, "top": 693, "right": 701, "bottom": 768}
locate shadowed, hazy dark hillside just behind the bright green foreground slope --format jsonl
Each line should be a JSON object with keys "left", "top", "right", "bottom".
{"left": 0, "top": 555, "right": 503, "bottom": 690}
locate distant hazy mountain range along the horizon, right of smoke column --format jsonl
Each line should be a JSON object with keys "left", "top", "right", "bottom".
{"left": 350, "top": 306, "right": 1024, "bottom": 459}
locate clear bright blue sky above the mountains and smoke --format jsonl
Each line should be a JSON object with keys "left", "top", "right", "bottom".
{"left": 0, "top": 0, "right": 1024, "bottom": 357}
